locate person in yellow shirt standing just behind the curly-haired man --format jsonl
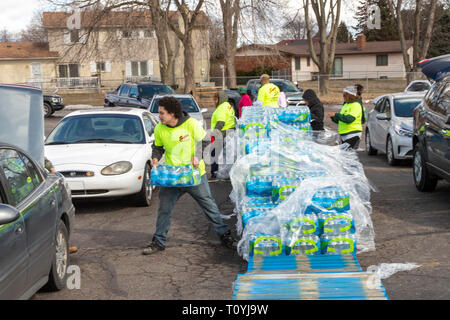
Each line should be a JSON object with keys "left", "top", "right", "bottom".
{"left": 211, "top": 91, "right": 236, "bottom": 178}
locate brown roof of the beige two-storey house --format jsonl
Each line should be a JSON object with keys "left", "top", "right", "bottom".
{"left": 42, "top": 10, "right": 211, "bottom": 28}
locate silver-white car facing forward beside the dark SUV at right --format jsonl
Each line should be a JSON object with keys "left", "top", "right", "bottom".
{"left": 366, "top": 93, "right": 424, "bottom": 165}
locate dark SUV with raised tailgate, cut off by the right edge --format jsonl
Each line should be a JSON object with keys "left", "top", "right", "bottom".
{"left": 413, "top": 54, "right": 450, "bottom": 191}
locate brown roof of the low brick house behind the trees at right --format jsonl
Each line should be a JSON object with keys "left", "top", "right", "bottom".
{"left": 278, "top": 40, "right": 413, "bottom": 56}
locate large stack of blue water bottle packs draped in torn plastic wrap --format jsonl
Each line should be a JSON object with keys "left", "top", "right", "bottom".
{"left": 230, "top": 106, "right": 375, "bottom": 260}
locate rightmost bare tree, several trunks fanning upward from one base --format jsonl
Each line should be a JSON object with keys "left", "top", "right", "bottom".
{"left": 388, "top": 0, "right": 437, "bottom": 82}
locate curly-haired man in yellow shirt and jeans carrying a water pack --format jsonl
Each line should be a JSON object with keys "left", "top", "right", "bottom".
{"left": 142, "top": 97, "right": 236, "bottom": 255}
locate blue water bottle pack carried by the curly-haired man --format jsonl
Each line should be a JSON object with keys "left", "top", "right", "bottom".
{"left": 150, "top": 164, "right": 201, "bottom": 187}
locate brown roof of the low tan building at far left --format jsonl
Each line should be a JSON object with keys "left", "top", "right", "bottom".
{"left": 0, "top": 42, "right": 59, "bottom": 59}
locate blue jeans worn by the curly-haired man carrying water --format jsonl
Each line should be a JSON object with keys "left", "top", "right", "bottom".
{"left": 153, "top": 174, "right": 230, "bottom": 246}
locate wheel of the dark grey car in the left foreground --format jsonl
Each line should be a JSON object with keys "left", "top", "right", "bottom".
{"left": 43, "top": 220, "right": 69, "bottom": 291}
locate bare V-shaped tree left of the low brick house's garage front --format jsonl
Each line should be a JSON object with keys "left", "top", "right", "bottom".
{"left": 303, "top": 0, "right": 341, "bottom": 94}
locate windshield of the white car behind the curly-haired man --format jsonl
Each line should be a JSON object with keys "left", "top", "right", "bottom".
{"left": 45, "top": 114, "right": 145, "bottom": 145}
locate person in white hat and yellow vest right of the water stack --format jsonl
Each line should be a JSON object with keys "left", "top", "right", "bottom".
{"left": 328, "top": 86, "right": 363, "bottom": 149}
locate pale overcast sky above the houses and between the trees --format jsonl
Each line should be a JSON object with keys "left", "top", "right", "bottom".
{"left": 0, "top": 0, "right": 358, "bottom": 33}
